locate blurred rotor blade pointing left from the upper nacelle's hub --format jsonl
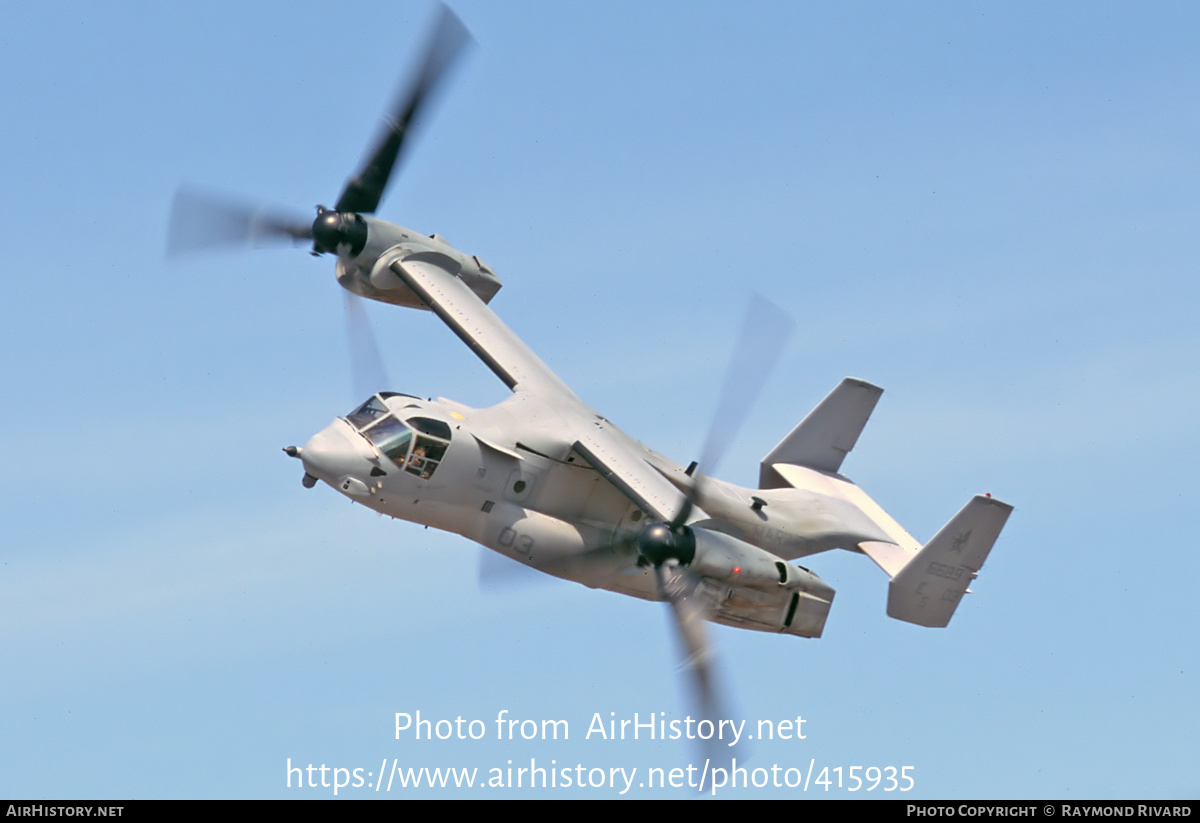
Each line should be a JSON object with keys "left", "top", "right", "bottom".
{"left": 167, "top": 188, "right": 312, "bottom": 254}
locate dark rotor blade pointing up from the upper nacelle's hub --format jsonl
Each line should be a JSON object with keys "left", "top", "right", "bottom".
{"left": 335, "top": 6, "right": 472, "bottom": 215}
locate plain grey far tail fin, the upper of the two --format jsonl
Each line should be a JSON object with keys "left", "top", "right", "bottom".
{"left": 760, "top": 377, "right": 883, "bottom": 488}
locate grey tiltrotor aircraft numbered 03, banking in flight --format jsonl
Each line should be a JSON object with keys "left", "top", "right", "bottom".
{"left": 170, "top": 4, "right": 1012, "bottom": 715}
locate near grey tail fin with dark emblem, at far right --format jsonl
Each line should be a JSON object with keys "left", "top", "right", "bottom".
{"left": 881, "top": 495, "right": 1013, "bottom": 627}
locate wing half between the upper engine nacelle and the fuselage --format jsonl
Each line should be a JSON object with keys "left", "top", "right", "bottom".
{"left": 389, "top": 252, "right": 582, "bottom": 406}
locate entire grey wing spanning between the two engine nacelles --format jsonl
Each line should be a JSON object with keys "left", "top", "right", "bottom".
{"left": 388, "top": 251, "right": 707, "bottom": 521}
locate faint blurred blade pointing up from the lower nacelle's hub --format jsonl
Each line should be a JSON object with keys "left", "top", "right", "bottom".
{"left": 671, "top": 294, "right": 796, "bottom": 530}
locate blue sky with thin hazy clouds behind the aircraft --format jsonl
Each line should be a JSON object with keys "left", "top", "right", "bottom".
{"left": 0, "top": 1, "right": 1200, "bottom": 799}
